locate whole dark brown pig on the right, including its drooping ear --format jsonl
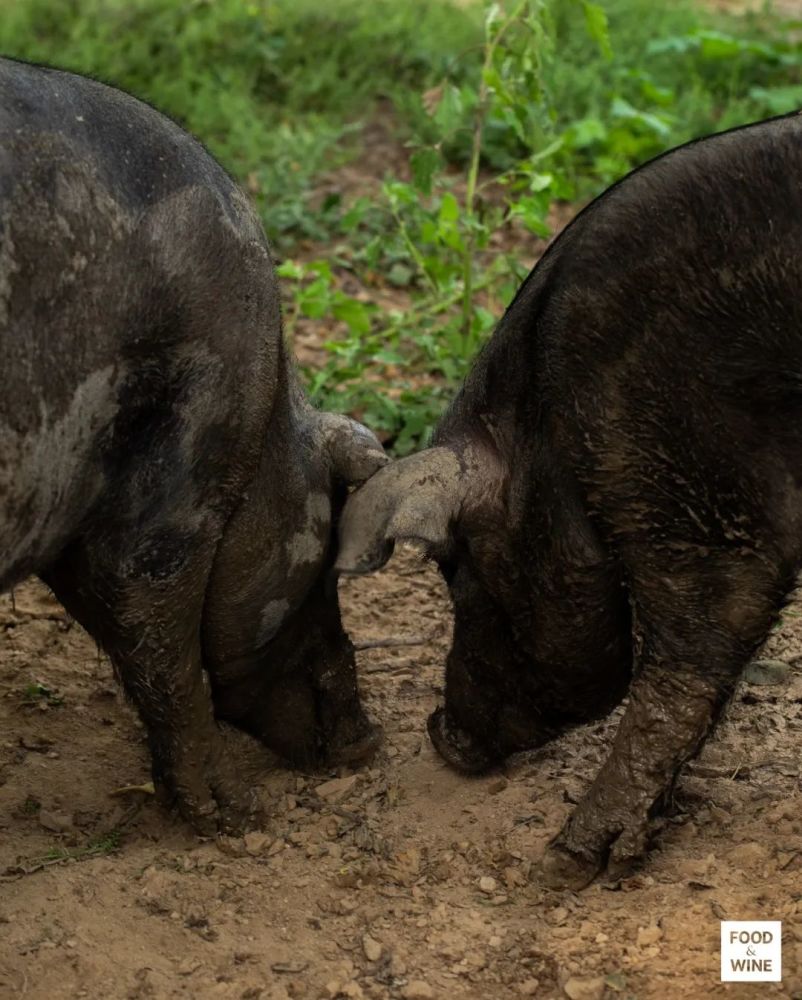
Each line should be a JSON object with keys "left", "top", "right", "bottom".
{"left": 337, "top": 115, "right": 802, "bottom": 887}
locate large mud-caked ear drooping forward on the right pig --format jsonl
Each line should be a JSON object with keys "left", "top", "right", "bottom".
{"left": 334, "top": 448, "right": 465, "bottom": 573}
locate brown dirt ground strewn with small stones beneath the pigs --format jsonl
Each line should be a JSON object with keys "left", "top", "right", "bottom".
{"left": 0, "top": 552, "right": 802, "bottom": 1000}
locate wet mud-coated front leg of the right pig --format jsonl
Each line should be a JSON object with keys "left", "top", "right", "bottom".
{"left": 544, "top": 556, "right": 783, "bottom": 888}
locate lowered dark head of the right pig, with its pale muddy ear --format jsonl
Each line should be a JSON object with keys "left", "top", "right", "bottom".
{"left": 335, "top": 428, "right": 631, "bottom": 772}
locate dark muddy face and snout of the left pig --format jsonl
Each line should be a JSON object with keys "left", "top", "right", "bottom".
{"left": 213, "top": 573, "right": 381, "bottom": 768}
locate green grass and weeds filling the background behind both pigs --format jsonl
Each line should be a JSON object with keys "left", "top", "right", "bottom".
{"left": 0, "top": 0, "right": 802, "bottom": 452}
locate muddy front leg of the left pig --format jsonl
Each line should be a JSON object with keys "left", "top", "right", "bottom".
{"left": 45, "top": 530, "right": 251, "bottom": 835}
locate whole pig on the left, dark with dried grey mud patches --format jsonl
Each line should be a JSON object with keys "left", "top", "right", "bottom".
{"left": 0, "top": 60, "right": 385, "bottom": 832}
